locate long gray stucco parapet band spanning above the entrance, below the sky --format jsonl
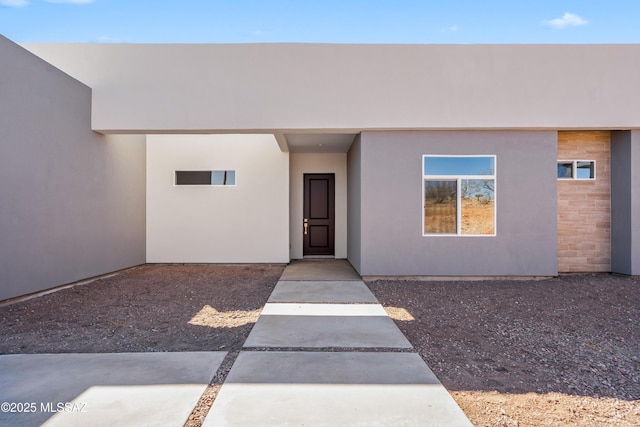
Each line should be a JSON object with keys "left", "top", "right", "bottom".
{"left": 25, "top": 43, "right": 640, "bottom": 133}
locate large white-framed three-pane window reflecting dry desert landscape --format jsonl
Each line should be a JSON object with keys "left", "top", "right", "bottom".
{"left": 422, "top": 154, "right": 496, "bottom": 236}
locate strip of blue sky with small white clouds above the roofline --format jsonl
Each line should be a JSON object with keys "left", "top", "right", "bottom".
{"left": 0, "top": 0, "right": 640, "bottom": 43}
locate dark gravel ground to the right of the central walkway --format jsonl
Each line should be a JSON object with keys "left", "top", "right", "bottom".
{"left": 368, "top": 274, "right": 640, "bottom": 427}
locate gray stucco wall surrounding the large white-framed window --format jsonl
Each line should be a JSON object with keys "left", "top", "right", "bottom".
{"left": 358, "top": 131, "right": 557, "bottom": 276}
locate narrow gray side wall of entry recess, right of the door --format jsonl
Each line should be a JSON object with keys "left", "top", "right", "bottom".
{"left": 347, "top": 135, "right": 362, "bottom": 272}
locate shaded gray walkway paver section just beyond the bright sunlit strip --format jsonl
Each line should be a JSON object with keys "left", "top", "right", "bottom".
{"left": 268, "top": 280, "right": 378, "bottom": 304}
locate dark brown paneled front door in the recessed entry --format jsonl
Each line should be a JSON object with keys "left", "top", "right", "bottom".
{"left": 303, "top": 173, "right": 335, "bottom": 255}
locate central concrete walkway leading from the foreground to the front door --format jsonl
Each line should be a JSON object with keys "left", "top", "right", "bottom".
{"left": 204, "top": 260, "right": 471, "bottom": 427}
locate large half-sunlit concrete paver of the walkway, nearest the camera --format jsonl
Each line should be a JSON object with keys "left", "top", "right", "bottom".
{"left": 203, "top": 352, "right": 471, "bottom": 427}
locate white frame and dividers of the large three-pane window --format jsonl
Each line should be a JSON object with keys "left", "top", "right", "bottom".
{"left": 421, "top": 154, "right": 498, "bottom": 237}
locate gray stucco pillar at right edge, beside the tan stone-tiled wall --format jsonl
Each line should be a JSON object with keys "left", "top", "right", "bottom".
{"left": 611, "top": 131, "right": 640, "bottom": 275}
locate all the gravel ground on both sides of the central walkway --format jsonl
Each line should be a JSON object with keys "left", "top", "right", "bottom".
{"left": 0, "top": 265, "right": 640, "bottom": 427}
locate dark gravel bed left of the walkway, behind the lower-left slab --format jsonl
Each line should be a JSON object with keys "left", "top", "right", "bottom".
{"left": 0, "top": 265, "right": 284, "bottom": 354}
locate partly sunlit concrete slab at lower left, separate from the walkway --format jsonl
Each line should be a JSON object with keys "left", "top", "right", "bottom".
{"left": 0, "top": 352, "right": 226, "bottom": 427}
